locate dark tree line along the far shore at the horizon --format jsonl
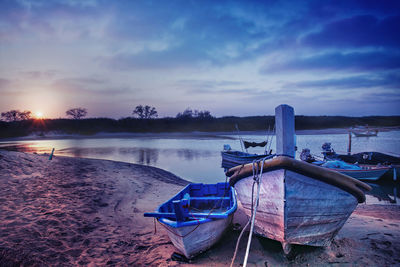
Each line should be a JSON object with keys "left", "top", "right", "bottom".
{"left": 0, "top": 112, "right": 400, "bottom": 138}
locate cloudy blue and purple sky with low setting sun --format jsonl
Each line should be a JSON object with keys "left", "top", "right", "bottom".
{"left": 0, "top": 0, "right": 400, "bottom": 119}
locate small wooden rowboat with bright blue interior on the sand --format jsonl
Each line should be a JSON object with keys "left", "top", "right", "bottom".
{"left": 144, "top": 183, "right": 237, "bottom": 258}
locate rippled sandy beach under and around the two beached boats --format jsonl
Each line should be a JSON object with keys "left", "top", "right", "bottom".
{"left": 0, "top": 150, "right": 400, "bottom": 266}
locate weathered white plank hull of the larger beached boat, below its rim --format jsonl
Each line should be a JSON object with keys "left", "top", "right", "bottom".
{"left": 235, "top": 169, "right": 358, "bottom": 246}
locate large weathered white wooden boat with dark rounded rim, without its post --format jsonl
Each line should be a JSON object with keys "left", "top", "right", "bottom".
{"left": 227, "top": 156, "right": 370, "bottom": 247}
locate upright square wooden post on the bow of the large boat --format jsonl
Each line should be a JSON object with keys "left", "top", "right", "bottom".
{"left": 275, "top": 105, "right": 296, "bottom": 158}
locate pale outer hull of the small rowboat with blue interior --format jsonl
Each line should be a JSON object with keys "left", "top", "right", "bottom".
{"left": 160, "top": 214, "right": 233, "bottom": 259}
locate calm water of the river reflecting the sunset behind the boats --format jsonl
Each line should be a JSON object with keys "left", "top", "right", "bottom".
{"left": 0, "top": 131, "right": 400, "bottom": 206}
